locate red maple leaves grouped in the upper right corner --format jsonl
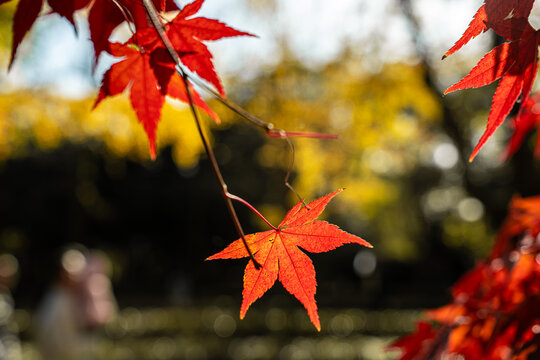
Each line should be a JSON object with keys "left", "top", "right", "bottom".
{"left": 443, "top": 0, "right": 540, "bottom": 160}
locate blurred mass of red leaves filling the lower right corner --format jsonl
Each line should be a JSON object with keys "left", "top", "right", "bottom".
{"left": 390, "top": 197, "right": 540, "bottom": 360}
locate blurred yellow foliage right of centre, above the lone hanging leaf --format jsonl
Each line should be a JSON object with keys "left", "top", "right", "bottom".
{"left": 236, "top": 57, "right": 441, "bottom": 217}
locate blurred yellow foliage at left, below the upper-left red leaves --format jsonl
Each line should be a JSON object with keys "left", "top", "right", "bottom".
{"left": 0, "top": 91, "right": 207, "bottom": 167}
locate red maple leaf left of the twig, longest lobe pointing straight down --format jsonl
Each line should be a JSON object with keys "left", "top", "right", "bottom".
{"left": 94, "top": 28, "right": 219, "bottom": 159}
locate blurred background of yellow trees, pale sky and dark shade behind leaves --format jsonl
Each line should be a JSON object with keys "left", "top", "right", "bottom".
{"left": 0, "top": 0, "right": 540, "bottom": 360}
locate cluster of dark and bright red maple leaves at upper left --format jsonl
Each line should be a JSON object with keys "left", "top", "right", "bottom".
{"left": 0, "top": 0, "right": 251, "bottom": 157}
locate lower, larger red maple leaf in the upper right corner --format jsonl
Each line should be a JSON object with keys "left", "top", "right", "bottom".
{"left": 445, "top": 18, "right": 538, "bottom": 161}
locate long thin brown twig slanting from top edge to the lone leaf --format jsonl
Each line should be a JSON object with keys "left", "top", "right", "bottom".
{"left": 143, "top": 0, "right": 261, "bottom": 269}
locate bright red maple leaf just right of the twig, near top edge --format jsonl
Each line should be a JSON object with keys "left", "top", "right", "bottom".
{"left": 167, "top": 0, "right": 253, "bottom": 95}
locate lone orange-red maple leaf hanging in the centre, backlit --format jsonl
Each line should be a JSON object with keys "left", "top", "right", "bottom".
{"left": 207, "top": 190, "right": 372, "bottom": 331}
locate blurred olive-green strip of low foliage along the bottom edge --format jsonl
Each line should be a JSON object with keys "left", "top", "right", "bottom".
{"left": 13, "top": 304, "right": 420, "bottom": 360}
